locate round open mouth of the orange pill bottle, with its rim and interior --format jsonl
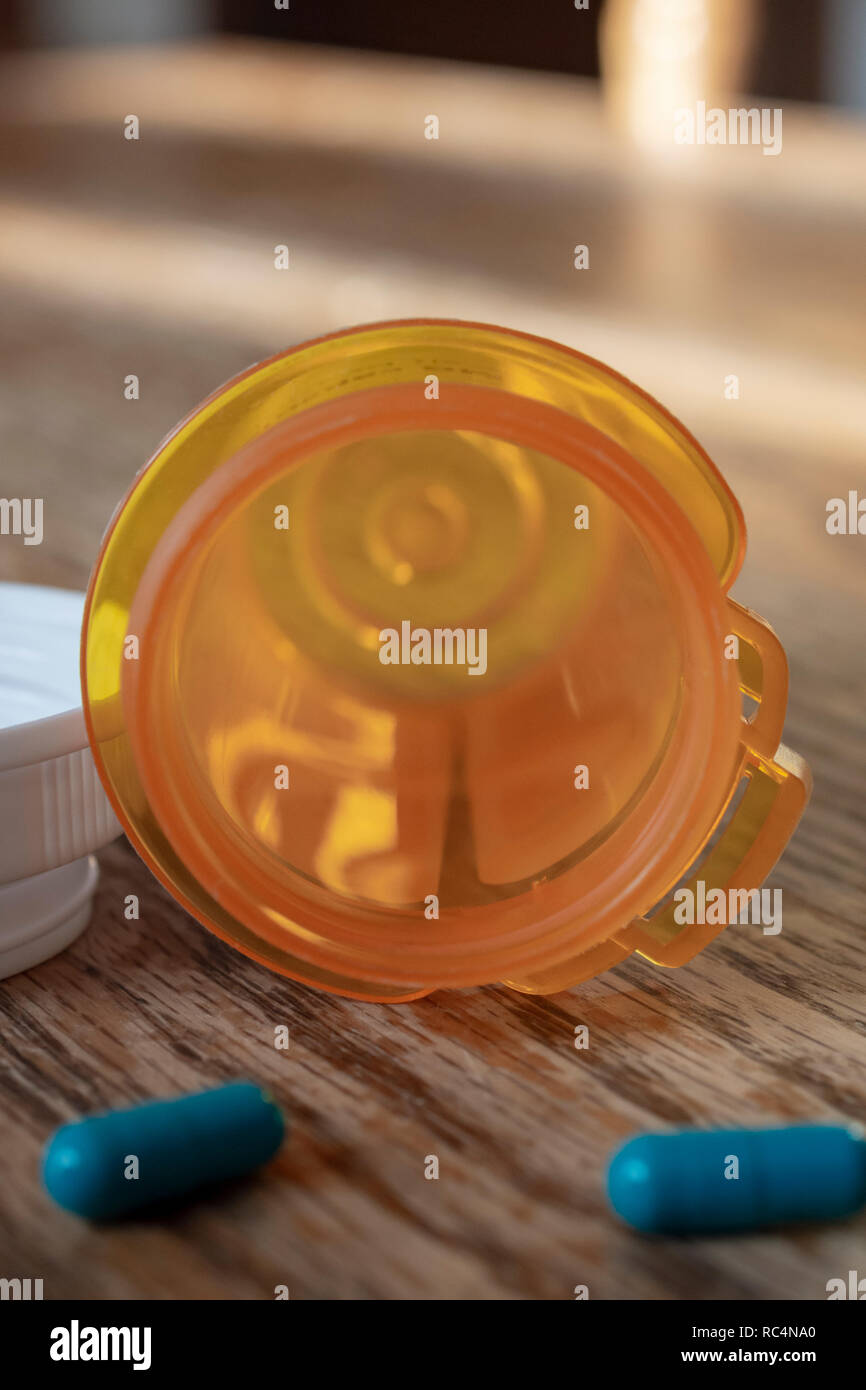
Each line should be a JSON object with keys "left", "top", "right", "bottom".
{"left": 85, "top": 322, "right": 738, "bottom": 998}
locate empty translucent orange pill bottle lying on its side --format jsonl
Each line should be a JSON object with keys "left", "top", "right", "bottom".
{"left": 82, "top": 320, "right": 808, "bottom": 1001}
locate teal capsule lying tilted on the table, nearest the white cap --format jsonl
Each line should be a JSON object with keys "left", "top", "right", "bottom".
{"left": 42, "top": 1081, "right": 285, "bottom": 1220}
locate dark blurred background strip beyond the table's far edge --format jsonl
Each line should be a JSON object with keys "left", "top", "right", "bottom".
{"left": 4, "top": 0, "right": 866, "bottom": 108}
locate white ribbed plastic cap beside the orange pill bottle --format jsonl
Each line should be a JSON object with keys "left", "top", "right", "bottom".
{"left": 0, "top": 584, "right": 121, "bottom": 979}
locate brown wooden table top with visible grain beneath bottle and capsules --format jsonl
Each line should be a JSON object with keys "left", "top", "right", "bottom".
{"left": 0, "top": 43, "right": 866, "bottom": 1298}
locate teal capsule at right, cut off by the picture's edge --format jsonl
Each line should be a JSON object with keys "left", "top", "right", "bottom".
{"left": 607, "top": 1125, "right": 866, "bottom": 1234}
